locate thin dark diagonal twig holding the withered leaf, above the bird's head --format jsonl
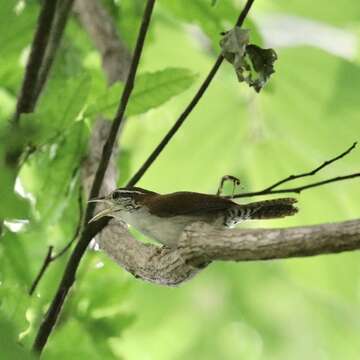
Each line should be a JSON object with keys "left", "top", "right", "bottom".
{"left": 127, "top": 0, "right": 254, "bottom": 187}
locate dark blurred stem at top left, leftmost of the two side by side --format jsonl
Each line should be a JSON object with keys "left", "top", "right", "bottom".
{"left": 13, "top": 0, "right": 58, "bottom": 123}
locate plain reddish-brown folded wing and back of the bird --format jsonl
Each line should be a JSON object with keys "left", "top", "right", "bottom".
{"left": 145, "top": 191, "right": 235, "bottom": 216}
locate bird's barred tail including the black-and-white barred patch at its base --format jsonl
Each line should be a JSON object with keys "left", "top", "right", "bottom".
{"left": 225, "top": 198, "right": 298, "bottom": 227}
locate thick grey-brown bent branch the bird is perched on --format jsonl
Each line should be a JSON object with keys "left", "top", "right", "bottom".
{"left": 100, "top": 220, "right": 360, "bottom": 286}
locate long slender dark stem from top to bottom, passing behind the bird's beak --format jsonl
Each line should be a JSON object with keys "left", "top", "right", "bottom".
{"left": 33, "top": 0, "right": 155, "bottom": 354}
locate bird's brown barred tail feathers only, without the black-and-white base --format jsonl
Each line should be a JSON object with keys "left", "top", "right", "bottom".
{"left": 240, "top": 198, "right": 298, "bottom": 219}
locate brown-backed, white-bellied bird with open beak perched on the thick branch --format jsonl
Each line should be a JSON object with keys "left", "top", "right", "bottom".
{"left": 89, "top": 187, "right": 298, "bottom": 248}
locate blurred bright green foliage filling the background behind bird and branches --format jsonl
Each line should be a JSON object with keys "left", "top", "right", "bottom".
{"left": 0, "top": 0, "right": 360, "bottom": 360}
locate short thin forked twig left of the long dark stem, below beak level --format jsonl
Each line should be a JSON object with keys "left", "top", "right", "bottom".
{"left": 29, "top": 186, "right": 84, "bottom": 296}
